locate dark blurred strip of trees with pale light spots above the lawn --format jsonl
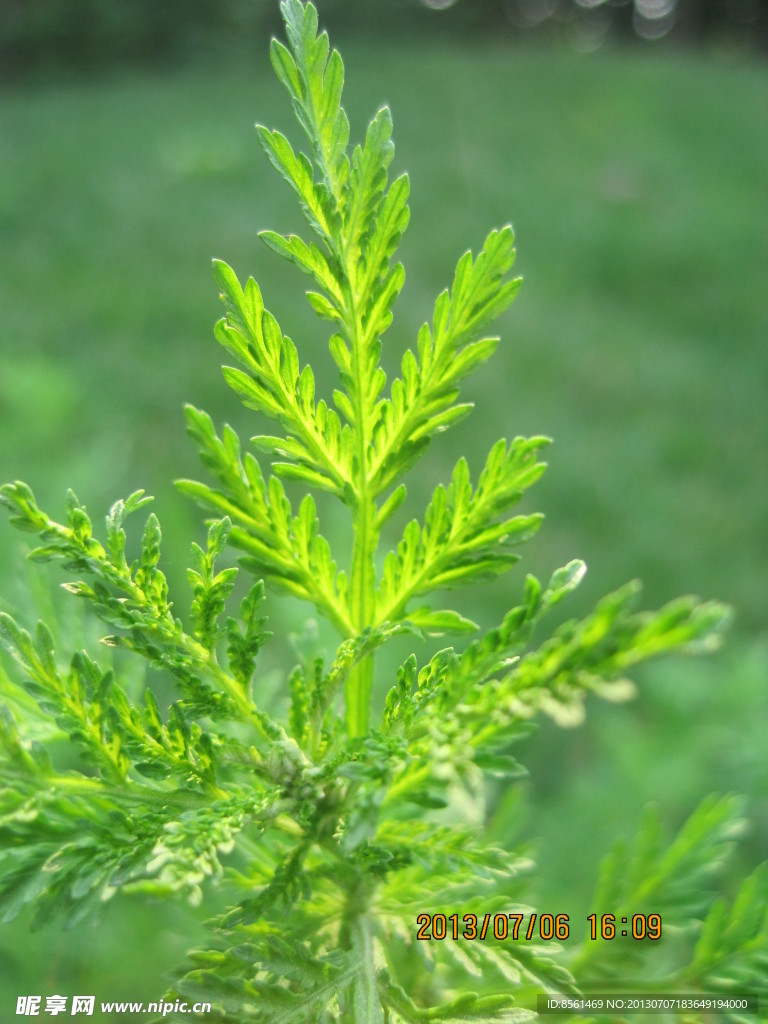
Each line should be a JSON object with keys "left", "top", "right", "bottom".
{"left": 0, "top": 0, "right": 768, "bottom": 78}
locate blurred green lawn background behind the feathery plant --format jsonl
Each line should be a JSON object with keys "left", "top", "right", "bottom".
{"left": 0, "top": 0, "right": 768, "bottom": 1019}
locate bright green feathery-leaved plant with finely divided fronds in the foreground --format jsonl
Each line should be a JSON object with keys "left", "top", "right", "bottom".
{"left": 0, "top": 0, "right": 768, "bottom": 1024}
